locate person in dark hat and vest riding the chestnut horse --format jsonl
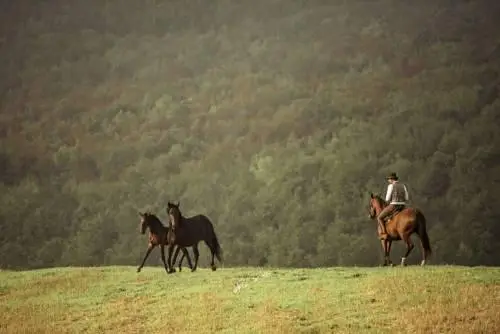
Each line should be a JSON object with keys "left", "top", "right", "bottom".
{"left": 377, "top": 173, "right": 409, "bottom": 239}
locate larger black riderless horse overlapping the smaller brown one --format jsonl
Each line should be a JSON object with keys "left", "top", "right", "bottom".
{"left": 167, "top": 202, "right": 222, "bottom": 272}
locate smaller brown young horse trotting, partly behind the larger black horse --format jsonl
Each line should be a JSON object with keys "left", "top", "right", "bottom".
{"left": 137, "top": 212, "right": 193, "bottom": 273}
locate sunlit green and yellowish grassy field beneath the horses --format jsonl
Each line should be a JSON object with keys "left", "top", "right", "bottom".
{"left": 0, "top": 266, "right": 500, "bottom": 333}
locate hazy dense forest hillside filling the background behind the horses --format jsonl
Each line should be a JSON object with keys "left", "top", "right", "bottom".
{"left": 0, "top": 0, "right": 500, "bottom": 268}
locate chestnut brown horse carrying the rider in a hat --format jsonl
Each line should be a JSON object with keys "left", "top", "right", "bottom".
{"left": 370, "top": 193, "right": 432, "bottom": 266}
